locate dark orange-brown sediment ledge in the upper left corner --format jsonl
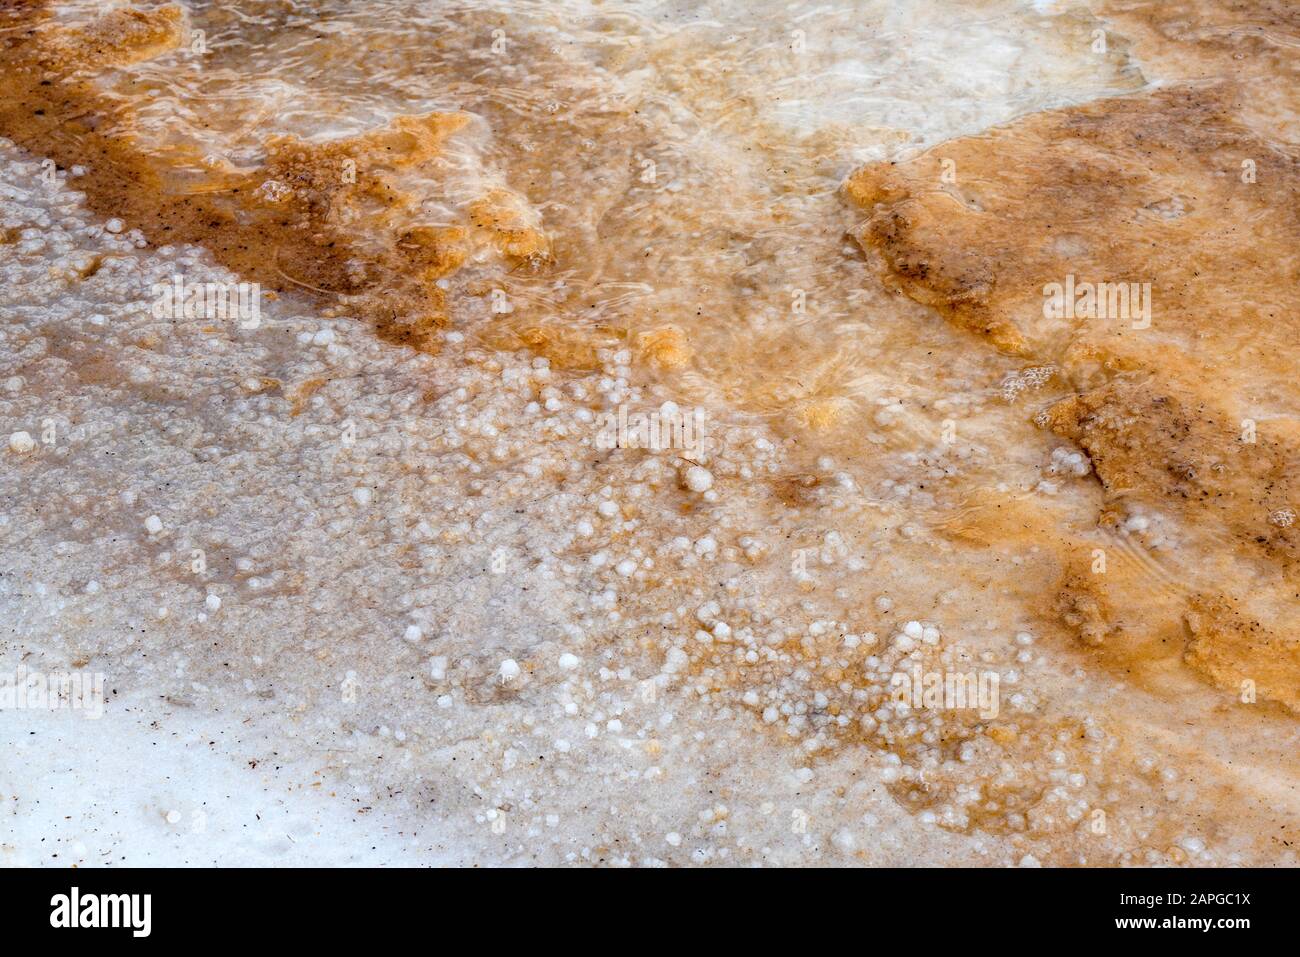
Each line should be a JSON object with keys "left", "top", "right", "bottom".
{"left": 0, "top": 1, "right": 549, "bottom": 351}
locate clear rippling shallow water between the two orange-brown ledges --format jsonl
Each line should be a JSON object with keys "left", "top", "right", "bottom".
{"left": 111, "top": 3, "right": 1141, "bottom": 428}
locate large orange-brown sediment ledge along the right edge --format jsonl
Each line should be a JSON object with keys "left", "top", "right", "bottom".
{"left": 845, "top": 87, "right": 1300, "bottom": 710}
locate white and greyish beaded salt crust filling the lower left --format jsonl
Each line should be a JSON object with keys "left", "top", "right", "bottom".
{"left": 0, "top": 144, "right": 1034, "bottom": 866}
